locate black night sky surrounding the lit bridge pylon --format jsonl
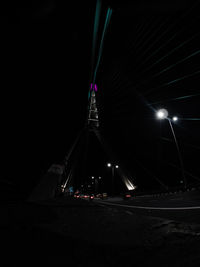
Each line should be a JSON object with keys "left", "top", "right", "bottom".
{"left": 1, "top": 0, "right": 200, "bottom": 197}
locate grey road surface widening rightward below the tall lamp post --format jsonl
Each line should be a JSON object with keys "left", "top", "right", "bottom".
{"left": 95, "top": 190, "right": 200, "bottom": 224}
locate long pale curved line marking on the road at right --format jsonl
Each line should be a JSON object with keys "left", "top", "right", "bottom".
{"left": 97, "top": 201, "right": 200, "bottom": 210}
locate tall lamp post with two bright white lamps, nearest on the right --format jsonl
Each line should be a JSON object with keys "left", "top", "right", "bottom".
{"left": 156, "top": 108, "right": 187, "bottom": 188}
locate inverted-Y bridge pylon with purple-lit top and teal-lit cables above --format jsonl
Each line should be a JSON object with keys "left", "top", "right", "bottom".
{"left": 60, "top": 0, "right": 135, "bottom": 195}
